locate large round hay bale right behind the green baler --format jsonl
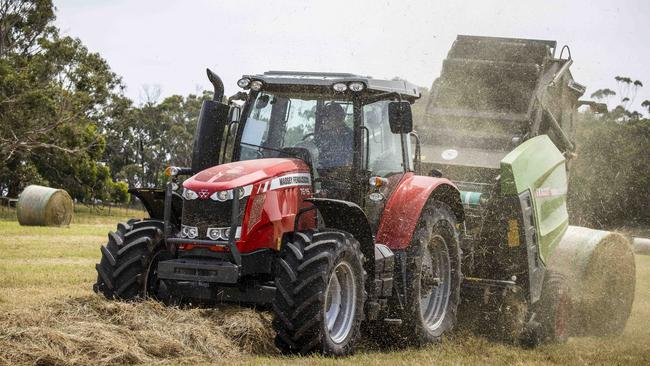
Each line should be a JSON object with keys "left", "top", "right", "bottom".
{"left": 549, "top": 226, "right": 636, "bottom": 336}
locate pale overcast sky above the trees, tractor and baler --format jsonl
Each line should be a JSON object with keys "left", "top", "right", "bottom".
{"left": 55, "top": 0, "right": 650, "bottom": 111}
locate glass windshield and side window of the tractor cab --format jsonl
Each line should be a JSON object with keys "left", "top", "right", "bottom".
{"left": 239, "top": 92, "right": 412, "bottom": 177}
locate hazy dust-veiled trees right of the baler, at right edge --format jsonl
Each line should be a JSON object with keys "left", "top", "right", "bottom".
{"left": 568, "top": 83, "right": 650, "bottom": 228}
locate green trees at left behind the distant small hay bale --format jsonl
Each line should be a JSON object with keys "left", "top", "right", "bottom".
{"left": 0, "top": 0, "right": 209, "bottom": 202}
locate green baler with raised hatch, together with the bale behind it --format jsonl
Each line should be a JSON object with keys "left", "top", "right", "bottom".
{"left": 418, "top": 36, "right": 634, "bottom": 344}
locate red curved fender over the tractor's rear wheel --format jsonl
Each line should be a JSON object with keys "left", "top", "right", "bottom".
{"left": 375, "top": 173, "right": 465, "bottom": 250}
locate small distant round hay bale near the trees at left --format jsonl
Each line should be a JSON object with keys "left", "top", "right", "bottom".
{"left": 16, "top": 185, "right": 73, "bottom": 226}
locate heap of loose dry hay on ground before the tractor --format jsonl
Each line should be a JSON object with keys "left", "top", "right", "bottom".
{"left": 0, "top": 295, "right": 277, "bottom": 365}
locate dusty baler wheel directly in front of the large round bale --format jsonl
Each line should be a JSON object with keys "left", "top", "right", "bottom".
{"left": 522, "top": 270, "right": 571, "bottom": 347}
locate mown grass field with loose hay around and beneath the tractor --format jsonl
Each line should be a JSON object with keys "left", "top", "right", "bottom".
{"left": 0, "top": 215, "right": 650, "bottom": 365}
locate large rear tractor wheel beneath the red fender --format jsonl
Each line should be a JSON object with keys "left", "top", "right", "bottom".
{"left": 390, "top": 202, "right": 462, "bottom": 346}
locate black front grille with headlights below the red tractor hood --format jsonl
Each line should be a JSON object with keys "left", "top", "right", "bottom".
{"left": 182, "top": 197, "right": 248, "bottom": 239}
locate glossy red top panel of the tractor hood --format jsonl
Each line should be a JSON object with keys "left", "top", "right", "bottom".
{"left": 183, "top": 159, "right": 309, "bottom": 192}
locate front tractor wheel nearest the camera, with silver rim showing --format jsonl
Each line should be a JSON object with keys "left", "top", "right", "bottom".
{"left": 272, "top": 229, "right": 366, "bottom": 356}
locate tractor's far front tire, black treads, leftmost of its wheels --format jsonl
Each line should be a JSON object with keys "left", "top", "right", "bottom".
{"left": 93, "top": 219, "right": 173, "bottom": 300}
